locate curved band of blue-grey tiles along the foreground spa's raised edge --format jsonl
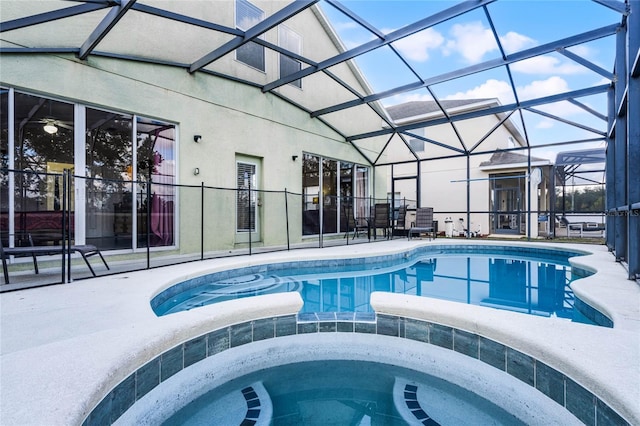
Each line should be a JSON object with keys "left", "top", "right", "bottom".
{"left": 83, "top": 313, "right": 630, "bottom": 426}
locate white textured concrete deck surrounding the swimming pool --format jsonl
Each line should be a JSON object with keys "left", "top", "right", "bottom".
{"left": 0, "top": 239, "right": 640, "bottom": 425}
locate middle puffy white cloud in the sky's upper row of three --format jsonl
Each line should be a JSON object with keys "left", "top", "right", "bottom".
{"left": 443, "top": 21, "right": 498, "bottom": 64}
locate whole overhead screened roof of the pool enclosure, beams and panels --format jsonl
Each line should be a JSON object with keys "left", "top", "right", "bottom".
{"left": 0, "top": 0, "right": 625, "bottom": 165}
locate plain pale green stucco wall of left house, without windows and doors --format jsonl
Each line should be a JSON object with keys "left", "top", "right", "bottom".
{"left": 0, "top": 1, "right": 386, "bottom": 251}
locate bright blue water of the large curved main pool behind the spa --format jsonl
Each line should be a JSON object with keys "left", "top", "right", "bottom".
{"left": 152, "top": 247, "right": 590, "bottom": 323}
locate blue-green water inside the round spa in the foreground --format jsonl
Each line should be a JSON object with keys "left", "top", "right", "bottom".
{"left": 163, "top": 360, "right": 525, "bottom": 426}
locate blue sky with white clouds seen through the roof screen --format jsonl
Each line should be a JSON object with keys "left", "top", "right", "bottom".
{"left": 322, "top": 0, "right": 621, "bottom": 159}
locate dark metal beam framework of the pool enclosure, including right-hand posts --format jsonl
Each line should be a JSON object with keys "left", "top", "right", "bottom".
{"left": 0, "top": 0, "right": 640, "bottom": 279}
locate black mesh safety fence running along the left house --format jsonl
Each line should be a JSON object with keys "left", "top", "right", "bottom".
{"left": 0, "top": 169, "right": 410, "bottom": 291}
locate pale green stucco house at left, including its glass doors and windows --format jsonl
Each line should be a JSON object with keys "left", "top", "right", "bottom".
{"left": 0, "top": 0, "right": 386, "bottom": 252}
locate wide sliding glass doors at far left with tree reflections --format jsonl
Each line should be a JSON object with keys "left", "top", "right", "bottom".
{"left": 0, "top": 91, "right": 176, "bottom": 249}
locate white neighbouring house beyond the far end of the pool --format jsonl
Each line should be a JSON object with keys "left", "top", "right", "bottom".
{"left": 387, "top": 99, "right": 551, "bottom": 237}
